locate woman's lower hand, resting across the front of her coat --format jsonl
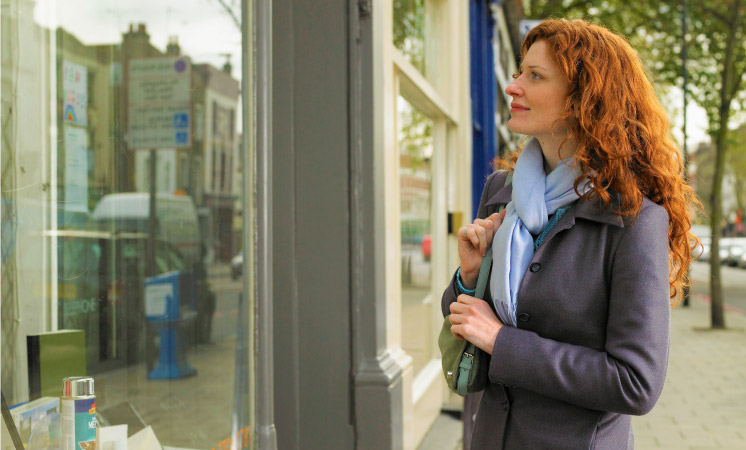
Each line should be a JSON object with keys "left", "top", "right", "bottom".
{"left": 448, "top": 294, "right": 503, "bottom": 355}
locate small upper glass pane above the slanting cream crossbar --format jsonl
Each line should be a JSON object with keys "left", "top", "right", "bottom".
{"left": 394, "top": 0, "right": 426, "bottom": 75}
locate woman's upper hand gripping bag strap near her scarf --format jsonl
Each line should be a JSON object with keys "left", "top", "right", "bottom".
{"left": 457, "top": 210, "right": 505, "bottom": 289}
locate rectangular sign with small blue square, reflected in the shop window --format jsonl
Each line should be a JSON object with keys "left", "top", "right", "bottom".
{"left": 127, "top": 56, "right": 192, "bottom": 149}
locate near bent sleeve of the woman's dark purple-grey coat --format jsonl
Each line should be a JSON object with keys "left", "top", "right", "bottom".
{"left": 489, "top": 205, "right": 670, "bottom": 415}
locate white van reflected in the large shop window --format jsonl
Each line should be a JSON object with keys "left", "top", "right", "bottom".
{"left": 91, "top": 192, "right": 200, "bottom": 266}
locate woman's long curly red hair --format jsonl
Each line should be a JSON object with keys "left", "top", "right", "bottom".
{"left": 495, "top": 19, "right": 701, "bottom": 304}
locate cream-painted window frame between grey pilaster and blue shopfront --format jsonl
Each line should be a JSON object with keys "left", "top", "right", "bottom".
{"left": 373, "top": 0, "right": 472, "bottom": 450}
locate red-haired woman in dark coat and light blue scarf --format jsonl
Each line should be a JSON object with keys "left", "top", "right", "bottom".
{"left": 442, "top": 20, "right": 698, "bottom": 450}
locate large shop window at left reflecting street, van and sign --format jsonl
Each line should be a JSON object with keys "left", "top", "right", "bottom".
{"left": 1, "top": 0, "right": 253, "bottom": 449}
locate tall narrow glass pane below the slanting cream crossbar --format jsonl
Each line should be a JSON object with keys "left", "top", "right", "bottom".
{"left": 397, "top": 97, "right": 433, "bottom": 373}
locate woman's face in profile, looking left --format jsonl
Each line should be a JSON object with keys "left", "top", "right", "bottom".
{"left": 505, "top": 41, "right": 570, "bottom": 142}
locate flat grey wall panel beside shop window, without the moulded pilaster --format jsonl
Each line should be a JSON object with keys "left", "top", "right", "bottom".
{"left": 272, "top": 0, "right": 355, "bottom": 450}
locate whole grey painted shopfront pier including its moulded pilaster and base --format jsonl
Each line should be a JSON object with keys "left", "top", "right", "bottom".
{"left": 272, "top": 0, "right": 403, "bottom": 450}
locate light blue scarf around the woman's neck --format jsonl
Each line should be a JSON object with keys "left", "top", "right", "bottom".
{"left": 490, "top": 138, "right": 590, "bottom": 326}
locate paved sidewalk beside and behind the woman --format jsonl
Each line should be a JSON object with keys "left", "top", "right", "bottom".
{"left": 419, "top": 293, "right": 746, "bottom": 450}
